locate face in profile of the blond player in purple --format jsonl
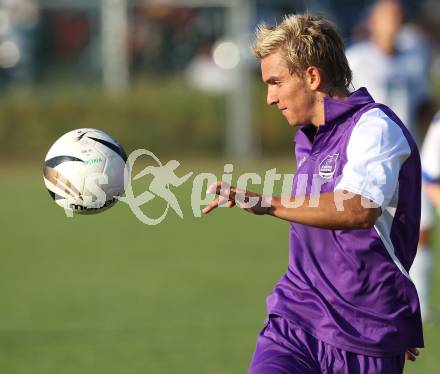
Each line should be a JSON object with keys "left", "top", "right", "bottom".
{"left": 261, "top": 51, "right": 315, "bottom": 126}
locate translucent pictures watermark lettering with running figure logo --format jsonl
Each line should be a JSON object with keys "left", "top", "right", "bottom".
{"left": 60, "top": 149, "right": 382, "bottom": 225}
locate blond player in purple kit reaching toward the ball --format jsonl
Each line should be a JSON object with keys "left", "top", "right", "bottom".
{"left": 203, "top": 15, "right": 423, "bottom": 374}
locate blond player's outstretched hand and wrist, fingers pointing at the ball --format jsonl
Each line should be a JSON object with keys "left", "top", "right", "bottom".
{"left": 202, "top": 181, "right": 271, "bottom": 214}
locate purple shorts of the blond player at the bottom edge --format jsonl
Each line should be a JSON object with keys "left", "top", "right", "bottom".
{"left": 248, "top": 316, "right": 405, "bottom": 374}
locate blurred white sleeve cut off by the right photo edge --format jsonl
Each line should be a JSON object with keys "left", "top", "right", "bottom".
{"left": 421, "top": 113, "right": 440, "bottom": 183}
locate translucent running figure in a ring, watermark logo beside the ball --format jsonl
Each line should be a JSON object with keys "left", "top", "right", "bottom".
{"left": 119, "top": 149, "right": 193, "bottom": 225}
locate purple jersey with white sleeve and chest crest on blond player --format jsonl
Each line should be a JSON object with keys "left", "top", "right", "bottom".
{"left": 267, "top": 88, "right": 423, "bottom": 356}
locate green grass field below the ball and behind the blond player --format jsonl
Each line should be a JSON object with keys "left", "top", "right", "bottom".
{"left": 0, "top": 162, "right": 440, "bottom": 374}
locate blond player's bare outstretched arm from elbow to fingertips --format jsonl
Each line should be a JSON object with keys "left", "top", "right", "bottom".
{"left": 203, "top": 182, "right": 381, "bottom": 230}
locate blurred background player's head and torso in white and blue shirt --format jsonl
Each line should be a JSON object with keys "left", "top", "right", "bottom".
{"left": 347, "top": 0, "right": 431, "bottom": 142}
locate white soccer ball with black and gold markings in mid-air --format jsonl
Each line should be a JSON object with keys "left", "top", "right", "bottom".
{"left": 43, "top": 129, "right": 128, "bottom": 214}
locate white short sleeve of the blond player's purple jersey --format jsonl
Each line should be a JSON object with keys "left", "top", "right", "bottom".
{"left": 335, "top": 108, "right": 411, "bottom": 208}
